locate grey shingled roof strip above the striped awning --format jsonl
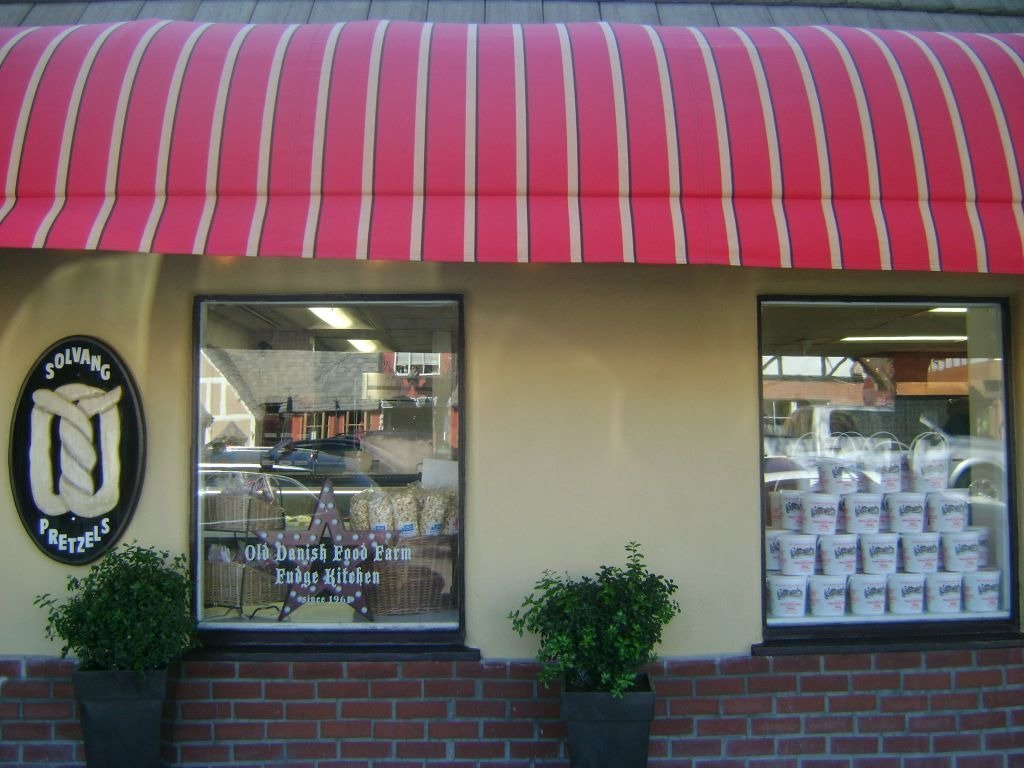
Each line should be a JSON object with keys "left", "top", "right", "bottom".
{"left": 0, "top": 0, "right": 1024, "bottom": 33}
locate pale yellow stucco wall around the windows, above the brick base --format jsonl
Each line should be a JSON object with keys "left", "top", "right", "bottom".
{"left": 0, "top": 252, "right": 1024, "bottom": 657}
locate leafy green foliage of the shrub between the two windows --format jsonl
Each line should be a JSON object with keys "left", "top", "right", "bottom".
{"left": 509, "top": 542, "right": 680, "bottom": 696}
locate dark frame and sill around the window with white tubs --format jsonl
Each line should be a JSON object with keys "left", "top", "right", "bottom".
{"left": 752, "top": 294, "right": 1024, "bottom": 655}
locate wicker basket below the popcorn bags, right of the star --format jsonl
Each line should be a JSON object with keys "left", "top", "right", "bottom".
{"left": 367, "top": 536, "right": 455, "bottom": 617}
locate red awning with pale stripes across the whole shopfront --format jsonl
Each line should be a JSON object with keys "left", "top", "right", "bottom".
{"left": 0, "top": 22, "right": 1024, "bottom": 272}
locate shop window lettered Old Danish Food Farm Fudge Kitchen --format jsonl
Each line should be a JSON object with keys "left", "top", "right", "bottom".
{"left": 195, "top": 297, "right": 462, "bottom": 638}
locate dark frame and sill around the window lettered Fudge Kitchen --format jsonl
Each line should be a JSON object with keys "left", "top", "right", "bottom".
{"left": 188, "top": 293, "right": 479, "bottom": 660}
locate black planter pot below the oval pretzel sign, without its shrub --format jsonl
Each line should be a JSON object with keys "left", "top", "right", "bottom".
{"left": 72, "top": 670, "right": 167, "bottom": 768}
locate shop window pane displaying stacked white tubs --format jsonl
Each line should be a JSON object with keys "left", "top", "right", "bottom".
{"left": 761, "top": 299, "right": 1016, "bottom": 638}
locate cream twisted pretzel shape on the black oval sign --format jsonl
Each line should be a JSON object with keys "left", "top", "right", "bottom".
{"left": 29, "top": 383, "right": 122, "bottom": 518}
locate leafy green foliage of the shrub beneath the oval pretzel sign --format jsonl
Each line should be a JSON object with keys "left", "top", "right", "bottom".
{"left": 35, "top": 544, "right": 198, "bottom": 673}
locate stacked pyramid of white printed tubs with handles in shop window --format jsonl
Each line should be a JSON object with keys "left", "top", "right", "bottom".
{"left": 765, "top": 436, "right": 1000, "bottom": 620}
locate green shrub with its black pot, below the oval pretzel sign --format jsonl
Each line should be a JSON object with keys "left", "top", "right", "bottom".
{"left": 35, "top": 544, "right": 197, "bottom": 768}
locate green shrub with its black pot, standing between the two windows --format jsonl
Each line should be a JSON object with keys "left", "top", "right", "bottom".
{"left": 509, "top": 542, "right": 680, "bottom": 768}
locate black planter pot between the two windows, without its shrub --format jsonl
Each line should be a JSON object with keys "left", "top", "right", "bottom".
{"left": 562, "top": 675, "right": 654, "bottom": 768}
